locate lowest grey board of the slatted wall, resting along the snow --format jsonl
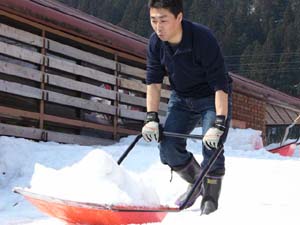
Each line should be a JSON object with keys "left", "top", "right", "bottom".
{"left": 0, "top": 123, "right": 115, "bottom": 145}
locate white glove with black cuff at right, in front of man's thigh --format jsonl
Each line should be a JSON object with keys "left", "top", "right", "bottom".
{"left": 203, "top": 116, "right": 226, "bottom": 150}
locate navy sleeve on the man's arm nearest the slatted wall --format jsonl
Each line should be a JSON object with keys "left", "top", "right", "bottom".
{"left": 146, "top": 34, "right": 165, "bottom": 84}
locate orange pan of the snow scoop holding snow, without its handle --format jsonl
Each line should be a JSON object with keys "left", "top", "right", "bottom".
{"left": 14, "top": 188, "right": 178, "bottom": 225}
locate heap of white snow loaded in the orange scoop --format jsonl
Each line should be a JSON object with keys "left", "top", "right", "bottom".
{"left": 30, "top": 149, "right": 160, "bottom": 206}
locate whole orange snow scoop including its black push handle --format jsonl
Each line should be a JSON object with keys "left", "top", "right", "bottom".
{"left": 14, "top": 132, "right": 223, "bottom": 225}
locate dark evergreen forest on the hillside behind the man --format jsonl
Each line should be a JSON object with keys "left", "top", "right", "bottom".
{"left": 59, "top": 0, "right": 300, "bottom": 98}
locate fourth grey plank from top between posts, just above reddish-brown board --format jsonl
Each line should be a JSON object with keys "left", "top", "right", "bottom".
{"left": 45, "top": 91, "right": 116, "bottom": 115}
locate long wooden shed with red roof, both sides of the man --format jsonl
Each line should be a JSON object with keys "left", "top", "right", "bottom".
{"left": 0, "top": 0, "right": 300, "bottom": 145}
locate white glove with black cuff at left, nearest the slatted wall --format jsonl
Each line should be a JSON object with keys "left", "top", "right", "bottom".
{"left": 142, "top": 112, "right": 162, "bottom": 142}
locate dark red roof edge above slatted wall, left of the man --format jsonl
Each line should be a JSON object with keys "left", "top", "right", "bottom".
{"left": 0, "top": 0, "right": 147, "bottom": 58}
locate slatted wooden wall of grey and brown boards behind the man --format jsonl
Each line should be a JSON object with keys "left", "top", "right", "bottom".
{"left": 0, "top": 22, "right": 170, "bottom": 145}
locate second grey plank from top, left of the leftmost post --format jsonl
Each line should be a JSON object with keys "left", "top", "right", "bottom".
{"left": 0, "top": 41, "right": 44, "bottom": 64}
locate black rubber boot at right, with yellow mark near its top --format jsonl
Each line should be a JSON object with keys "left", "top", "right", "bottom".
{"left": 201, "top": 176, "right": 222, "bottom": 215}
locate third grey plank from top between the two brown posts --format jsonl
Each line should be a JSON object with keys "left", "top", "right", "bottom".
{"left": 45, "top": 73, "right": 116, "bottom": 100}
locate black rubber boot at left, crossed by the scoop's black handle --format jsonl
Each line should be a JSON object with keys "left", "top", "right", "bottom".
{"left": 173, "top": 156, "right": 202, "bottom": 208}
